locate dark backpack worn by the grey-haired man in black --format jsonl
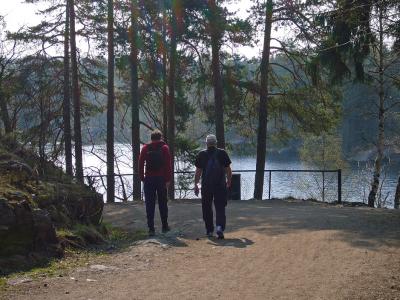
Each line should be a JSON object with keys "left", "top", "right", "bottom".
{"left": 202, "top": 149, "right": 225, "bottom": 189}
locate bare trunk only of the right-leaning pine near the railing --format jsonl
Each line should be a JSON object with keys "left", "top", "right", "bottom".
{"left": 254, "top": 0, "right": 272, "bottom": 200}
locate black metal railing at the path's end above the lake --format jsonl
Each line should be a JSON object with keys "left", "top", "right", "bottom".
{"left": 84, "top": 169, "right": 342, "bottom": 203}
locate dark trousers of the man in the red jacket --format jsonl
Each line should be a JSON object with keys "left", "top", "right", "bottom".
{"left": 144, "top": 176, "right": 168, "bottom": 230}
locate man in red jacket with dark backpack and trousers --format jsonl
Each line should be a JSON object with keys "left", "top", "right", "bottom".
{"left": 139, "top": 130, "right": 172, "bottom": 236}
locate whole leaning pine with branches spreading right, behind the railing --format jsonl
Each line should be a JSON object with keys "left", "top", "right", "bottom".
{"left": 250, "top": 0, "right": 337, "bottom": 199}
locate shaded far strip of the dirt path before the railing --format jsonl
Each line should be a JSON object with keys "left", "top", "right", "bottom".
{"left": 105, "top": 200, "right": 400, "bottom": 250}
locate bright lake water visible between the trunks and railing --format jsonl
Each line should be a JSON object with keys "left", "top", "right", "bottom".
{"left": 76, "top": 144, "right": 399, "bottom": 207}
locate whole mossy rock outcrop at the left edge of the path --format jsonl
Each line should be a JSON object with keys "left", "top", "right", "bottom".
{"left": 0, "top": 138, "right": 104, "bottom": 273}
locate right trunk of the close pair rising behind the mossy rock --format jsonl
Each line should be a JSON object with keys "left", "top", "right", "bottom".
{"left": 69, "top": 0, "right": 83, "bottom": 183}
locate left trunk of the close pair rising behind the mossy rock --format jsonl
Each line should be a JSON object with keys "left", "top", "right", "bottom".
{"left": 63, "top": 1, "right": 73, "bottom": 176}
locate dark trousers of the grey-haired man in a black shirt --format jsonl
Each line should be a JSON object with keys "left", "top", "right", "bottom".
{"left": 201, "top": 187, "right": 227, "bottom": 232}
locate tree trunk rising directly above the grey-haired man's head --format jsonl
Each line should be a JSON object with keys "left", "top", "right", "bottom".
{"left": 209, "top": 0, "right": 225, "bottom": 148}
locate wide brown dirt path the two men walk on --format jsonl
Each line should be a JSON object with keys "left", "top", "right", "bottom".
{"left": 5, "top": 201, "right": 400, "bottom": 299}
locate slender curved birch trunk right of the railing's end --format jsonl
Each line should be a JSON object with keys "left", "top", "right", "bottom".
{"left": 368, "top": 8, "right": 385, "bottom": 207}
